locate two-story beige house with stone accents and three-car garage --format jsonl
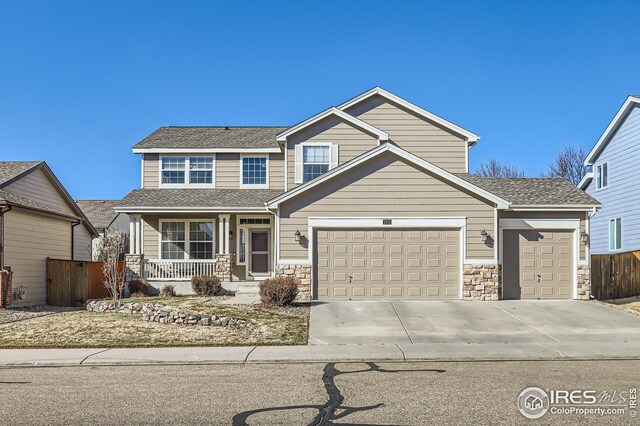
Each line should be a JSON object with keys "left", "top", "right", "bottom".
{"left": 116, "top": 88, "right": 599, "bottom": 300}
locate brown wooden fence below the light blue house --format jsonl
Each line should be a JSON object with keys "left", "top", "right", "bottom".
{"left": 591, "top": 251, "right": 640, "bottom": 300}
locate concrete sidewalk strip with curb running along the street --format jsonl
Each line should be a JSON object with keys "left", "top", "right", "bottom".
{"left": 0, "top": 341, "right": 640, "bottom": 366}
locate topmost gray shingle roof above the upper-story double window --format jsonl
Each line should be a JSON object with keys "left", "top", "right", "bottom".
{"left": 133, "top": 126, "right": 287, "bottom": 149}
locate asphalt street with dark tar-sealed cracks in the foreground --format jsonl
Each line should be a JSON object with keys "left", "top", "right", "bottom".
{"left": 0, "top": 360, "right": 640, "bottom": 425}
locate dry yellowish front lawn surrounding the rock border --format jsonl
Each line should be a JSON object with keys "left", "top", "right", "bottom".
{"left": 0, "top": 297, "right": 309, "bottom": 348}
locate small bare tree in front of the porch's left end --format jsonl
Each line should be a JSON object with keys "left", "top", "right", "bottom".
{"left": 99, "top": 231, "right": 127, "bottom": 306}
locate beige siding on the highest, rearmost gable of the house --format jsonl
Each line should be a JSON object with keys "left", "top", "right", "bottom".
{"left": 346, "top": 95, "right": 467, "bottom": 173}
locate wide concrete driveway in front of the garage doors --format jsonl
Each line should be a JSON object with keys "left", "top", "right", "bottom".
{"left": 309, "top": 300, "right": 640, "bottom": 345}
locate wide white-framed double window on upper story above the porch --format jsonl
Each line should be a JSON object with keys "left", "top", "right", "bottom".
{"left": 160, "top": 156, "right": 214, "bottom": 186}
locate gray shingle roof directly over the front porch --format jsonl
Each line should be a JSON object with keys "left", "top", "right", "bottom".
{"left": 118, "top": 188, "right": 282, "bottom": 208}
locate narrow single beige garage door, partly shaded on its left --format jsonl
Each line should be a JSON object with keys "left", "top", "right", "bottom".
{"left": 503, "top": 230, "right": 573, "bottom": 299}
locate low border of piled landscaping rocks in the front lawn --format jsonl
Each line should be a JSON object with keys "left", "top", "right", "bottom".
{"left": 86, "top": 300, "right": 252, "bottom": 328}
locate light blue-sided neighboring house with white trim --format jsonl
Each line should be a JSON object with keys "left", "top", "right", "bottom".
{"left": 579, "top": 95, "right": 640, "bottom": 254}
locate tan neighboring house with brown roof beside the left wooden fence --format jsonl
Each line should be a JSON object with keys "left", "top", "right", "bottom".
{"left": 0, "top": 161, "right": 97, "bottom": 304}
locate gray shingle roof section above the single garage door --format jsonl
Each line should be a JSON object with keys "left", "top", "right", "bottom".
{"left": 456, "top": 173, "right": 600, "bottom": 206}
